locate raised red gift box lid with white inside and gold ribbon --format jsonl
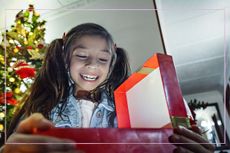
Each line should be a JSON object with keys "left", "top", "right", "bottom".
{"left": 114, "top": 53, "right": 190, "bottom": 128}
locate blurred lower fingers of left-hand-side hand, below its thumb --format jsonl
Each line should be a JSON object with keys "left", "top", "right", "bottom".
{"left": 4, "top": 134, "right": 76, "bottom": 153}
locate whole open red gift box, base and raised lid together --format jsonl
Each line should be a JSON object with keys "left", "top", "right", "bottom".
{"left": 32, "top": 54, "right": 190, "bottom": 153}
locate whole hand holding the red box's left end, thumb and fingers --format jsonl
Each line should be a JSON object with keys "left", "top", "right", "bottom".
{"left": 3, "top": 113, "right": 82, "bottom": 153}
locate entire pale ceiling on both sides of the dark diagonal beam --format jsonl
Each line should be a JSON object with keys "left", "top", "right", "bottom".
{"left": 0, "top": 0, "right": 230, "bottom": 95}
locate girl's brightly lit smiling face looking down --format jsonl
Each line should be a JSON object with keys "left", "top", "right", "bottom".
{"left": 70, "top": 36, "right": 112, "bottom": 91}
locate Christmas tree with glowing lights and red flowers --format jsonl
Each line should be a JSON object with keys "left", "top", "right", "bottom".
{"left": 0, "top": 5, "right": 46, "bottom": 143}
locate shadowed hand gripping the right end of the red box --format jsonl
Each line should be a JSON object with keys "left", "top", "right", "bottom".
{"left": 169, "top": 126, "right": 215, "bottom": 153}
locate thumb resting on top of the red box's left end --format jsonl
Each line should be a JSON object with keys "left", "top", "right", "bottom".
{"left": 16, "top": 113, "right": 54, "bottom": 134}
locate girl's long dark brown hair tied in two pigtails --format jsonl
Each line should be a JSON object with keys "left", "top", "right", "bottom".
{"left": 7, "top": 23, "right": 130, "bottom": 136}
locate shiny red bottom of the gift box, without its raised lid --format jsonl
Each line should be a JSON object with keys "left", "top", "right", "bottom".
{"left": 34, "top": 128, "right": 175, "bottom": 153}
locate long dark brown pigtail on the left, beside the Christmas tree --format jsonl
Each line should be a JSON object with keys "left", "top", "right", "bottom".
{"left": 8, "top": 39, "right": 69, "bottom": 134}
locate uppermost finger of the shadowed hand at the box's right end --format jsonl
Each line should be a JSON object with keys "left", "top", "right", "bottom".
{"left": 174, "top": 126, "right": 215, "bottom": 150}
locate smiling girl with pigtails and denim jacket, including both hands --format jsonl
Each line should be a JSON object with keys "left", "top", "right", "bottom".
{"left": 3, "top": 23, "right": 214, "bottom": 153}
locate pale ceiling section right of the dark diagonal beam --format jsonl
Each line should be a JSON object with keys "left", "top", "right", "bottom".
{"left": 156, "top": 0, "right": 230, "bottom": 94}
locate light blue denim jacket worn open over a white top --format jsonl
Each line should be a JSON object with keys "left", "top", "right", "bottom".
{"left": 50, "top": 92, "right": 117, "bottom": 128}
